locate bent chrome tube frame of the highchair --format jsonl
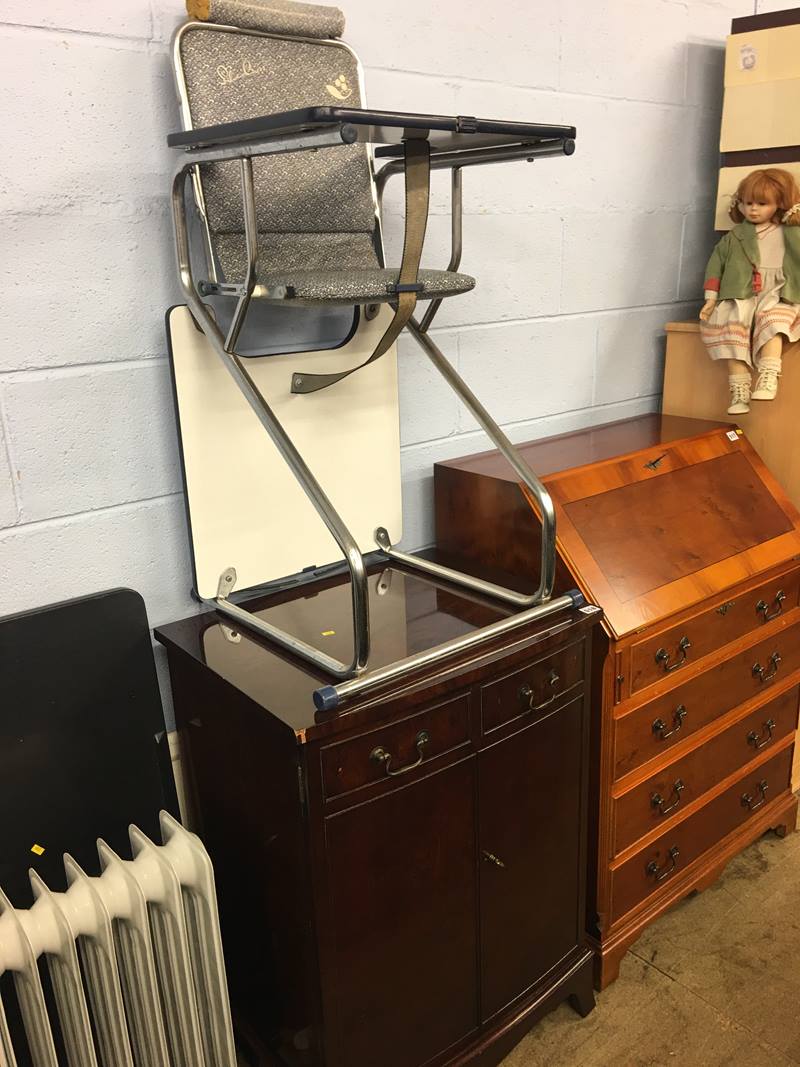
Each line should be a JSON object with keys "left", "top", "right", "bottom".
{"left": 172, "top": 127, "right": 571, "bottom": 691}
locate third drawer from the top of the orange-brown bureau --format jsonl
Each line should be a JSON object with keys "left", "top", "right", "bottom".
{"left": 613, "top": 686, "right": 800, "bottom": 854}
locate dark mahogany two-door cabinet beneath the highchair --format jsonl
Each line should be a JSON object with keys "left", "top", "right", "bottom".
{"left": 157, "top": 566, "right": 601, "bottom": 1067}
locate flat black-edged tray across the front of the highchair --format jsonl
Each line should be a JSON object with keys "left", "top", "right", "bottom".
{"left": 166, "top": 107, "right": 575, "bottom": 157}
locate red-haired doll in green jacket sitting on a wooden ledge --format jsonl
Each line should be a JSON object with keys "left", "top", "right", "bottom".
{"left": 700, "top": 168, "right": 800, "bottom": 415}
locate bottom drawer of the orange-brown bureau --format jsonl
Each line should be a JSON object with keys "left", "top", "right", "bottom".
{"left": 611, "top": 745, "right": 793, "bottom": 921}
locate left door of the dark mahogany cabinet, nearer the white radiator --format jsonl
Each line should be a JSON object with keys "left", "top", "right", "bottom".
{"left": 325, "top": 755, "right": 478, "bottom": 1067}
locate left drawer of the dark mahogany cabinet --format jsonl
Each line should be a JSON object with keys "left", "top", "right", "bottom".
{"left": 320, "top": 694, "right": 469, "bottom": 799}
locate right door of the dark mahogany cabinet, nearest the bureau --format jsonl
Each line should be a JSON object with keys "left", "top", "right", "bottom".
{"left": 479, "top": 697, "right": 583, "bottom": 1020}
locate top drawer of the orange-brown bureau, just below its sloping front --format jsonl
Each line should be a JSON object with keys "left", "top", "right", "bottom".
{"left": 630, "top": 571, "right": 800, "bottom": 692}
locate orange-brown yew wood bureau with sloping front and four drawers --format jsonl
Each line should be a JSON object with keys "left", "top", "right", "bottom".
{"left": 434, "top": 415, "right": 800, "bottom": 988}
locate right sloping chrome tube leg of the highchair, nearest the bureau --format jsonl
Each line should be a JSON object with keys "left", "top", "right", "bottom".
{"left": 406, "top": 319, "right": 556, "bottom": 603}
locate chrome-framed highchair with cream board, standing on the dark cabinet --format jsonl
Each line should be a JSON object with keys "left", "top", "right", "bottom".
{"left": 169, "top": 0, "right": 581, "bottom": 711}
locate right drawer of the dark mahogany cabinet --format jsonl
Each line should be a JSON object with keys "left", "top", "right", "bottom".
{"left": 480, "top": 640, "right": 585, "bottom": 734}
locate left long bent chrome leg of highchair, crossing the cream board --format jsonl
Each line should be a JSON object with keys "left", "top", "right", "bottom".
{"left": 172, "top": 170, "right": 369, "bottom": 674}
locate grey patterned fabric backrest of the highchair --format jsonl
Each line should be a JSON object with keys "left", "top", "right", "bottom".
{"left": 174, "top": 14, "right": 382, "bottom": 282}
